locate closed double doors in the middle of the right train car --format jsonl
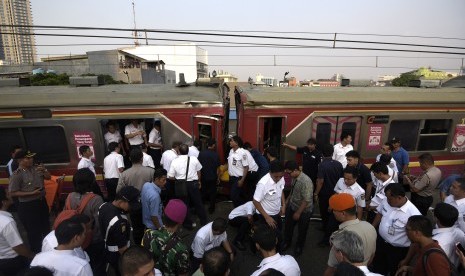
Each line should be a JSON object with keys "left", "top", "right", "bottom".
{"left": 312, "top": 116, "right": 362, "bottom": 150}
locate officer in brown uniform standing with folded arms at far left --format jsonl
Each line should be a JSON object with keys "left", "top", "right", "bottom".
{"left": 10, "top": 150, "right": 50, "bottom": 252}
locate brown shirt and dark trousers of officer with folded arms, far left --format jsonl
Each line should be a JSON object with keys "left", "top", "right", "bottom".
{"left": 10, "top": 167, "right": 50, "bottom": 252}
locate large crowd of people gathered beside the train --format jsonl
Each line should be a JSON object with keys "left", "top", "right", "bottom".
{"left": 0, "top": 123, "right": 465, "bottom": 276}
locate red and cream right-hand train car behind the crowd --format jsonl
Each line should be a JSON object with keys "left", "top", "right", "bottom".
{"left": 235, "top": 87, "right": 465, "bottom": 176}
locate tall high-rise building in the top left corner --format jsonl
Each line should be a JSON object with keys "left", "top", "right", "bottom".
{"left": 0, "top": 0, "right": 36, "bottom": 64}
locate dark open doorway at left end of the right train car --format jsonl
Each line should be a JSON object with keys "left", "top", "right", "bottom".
{"left": 257, "top": 117, "right": 285, "bottom": 159}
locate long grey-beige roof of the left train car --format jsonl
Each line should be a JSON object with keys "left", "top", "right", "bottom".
{"left": 0, "top": 84, "right": 223, "bottom": 108}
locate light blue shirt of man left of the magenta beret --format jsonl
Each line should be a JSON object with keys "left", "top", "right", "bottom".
{"left": 141, "top": 182, "right": 163, "bottom": 230}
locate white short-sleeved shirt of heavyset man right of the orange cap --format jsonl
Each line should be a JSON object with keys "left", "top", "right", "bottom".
{"left": 376, "top": 198, "right": 421, "bottom": 247}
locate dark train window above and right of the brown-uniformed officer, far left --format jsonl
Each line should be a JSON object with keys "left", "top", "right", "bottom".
{"left": 22, "top": 126, "right": 69, "bottom": 163}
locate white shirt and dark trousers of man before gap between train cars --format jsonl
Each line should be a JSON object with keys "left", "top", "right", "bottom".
{"left": 228, "top": 148, "right": 249, "bottom": 207}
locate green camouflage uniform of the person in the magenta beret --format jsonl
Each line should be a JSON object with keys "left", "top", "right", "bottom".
{"left": 142, "top": 227, "right": 189, "bottom": 276}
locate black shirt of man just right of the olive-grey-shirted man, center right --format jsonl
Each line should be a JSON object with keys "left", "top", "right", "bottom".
{"left": 318, "top": 157, "right": 343, "bottom": 196}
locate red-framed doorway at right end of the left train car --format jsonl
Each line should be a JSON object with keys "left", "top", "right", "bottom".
{"left": 192, "top": 115, "right": 221, "bottom": 153}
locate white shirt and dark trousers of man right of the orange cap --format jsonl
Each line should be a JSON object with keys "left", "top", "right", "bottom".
{"left": 373, "top": 198, "right": 421, "bottom": 275}
